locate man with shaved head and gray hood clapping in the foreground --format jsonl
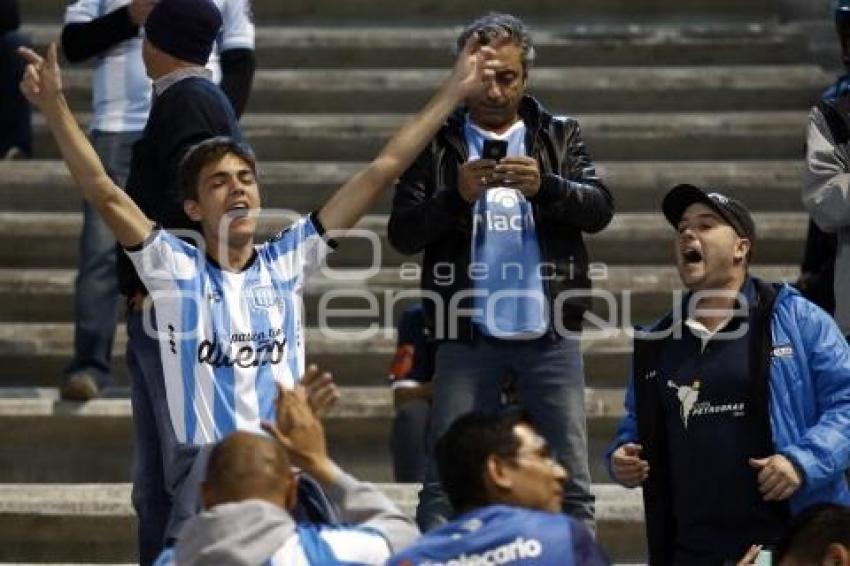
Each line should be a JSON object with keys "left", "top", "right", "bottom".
{"left": 156, "top": 386, "right": 419, "bottom": 566}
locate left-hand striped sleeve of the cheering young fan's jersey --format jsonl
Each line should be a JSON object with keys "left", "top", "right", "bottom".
{"left": 124, "top": 229, "right": 201, "bottom": 292}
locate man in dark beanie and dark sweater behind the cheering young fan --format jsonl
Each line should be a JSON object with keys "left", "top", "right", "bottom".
{"left": 61, "top": 0, "right": 253, "bottom": 564}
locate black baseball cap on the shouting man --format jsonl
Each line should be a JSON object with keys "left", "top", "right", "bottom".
{"left": 661, "top": 184, "right": 756, "bottom": 246}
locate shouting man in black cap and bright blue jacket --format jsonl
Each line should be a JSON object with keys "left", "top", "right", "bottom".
{"left": 606, "top": 185, "right": 850, "bottom": 565}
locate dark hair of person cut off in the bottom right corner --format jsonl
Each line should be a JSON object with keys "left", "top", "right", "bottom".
{"left": 773, "top": 503, "right": 850, "bottom": 564}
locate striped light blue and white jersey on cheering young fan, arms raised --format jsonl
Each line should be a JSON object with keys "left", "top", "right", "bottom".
{"left": 127, "top": 216, "right": 331, "bottom": 445}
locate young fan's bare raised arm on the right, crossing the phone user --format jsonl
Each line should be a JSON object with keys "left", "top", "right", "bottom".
{"left": 319, "top": 37, "right": 496, "bottom": 230}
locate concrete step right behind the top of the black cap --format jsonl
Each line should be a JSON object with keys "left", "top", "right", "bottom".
{"left": 0, "top": 160, "right": 804, "bottom": 214}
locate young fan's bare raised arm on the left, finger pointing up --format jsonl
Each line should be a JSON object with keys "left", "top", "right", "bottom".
{"left": 18, "top": 43, "right": 153, "bottom": 247}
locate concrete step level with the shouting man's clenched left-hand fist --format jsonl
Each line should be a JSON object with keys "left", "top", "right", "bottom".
{"left": 0, "top": 386, "right": 624, "bottom": 483}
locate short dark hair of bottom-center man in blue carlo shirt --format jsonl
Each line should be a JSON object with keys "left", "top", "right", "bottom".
{"left": 434, "top": 411, "right": 528, "bottom": 512}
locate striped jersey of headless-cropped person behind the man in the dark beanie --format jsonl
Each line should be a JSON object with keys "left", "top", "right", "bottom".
{"left": 65, "top": 0, "right": 254, "bottom": 132}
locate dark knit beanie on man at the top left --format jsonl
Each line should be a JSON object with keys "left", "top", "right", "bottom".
{"left": 145, "top": 0, "right": 221, "bottom": 65}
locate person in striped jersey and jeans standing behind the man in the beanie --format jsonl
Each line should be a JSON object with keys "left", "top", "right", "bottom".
{"left": 59, "top": 0, "right": 254, "bottom": 401}
